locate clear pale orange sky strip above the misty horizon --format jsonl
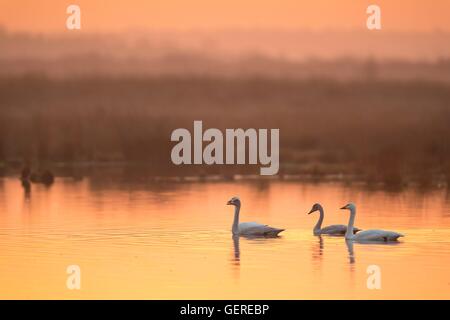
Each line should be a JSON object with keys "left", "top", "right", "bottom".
{"left": 0, "top": 0, "right": 450, "bottom": 32}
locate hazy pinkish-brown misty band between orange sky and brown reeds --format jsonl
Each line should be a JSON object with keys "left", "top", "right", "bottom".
{"left": 0, "top": 28, "right": 450, "bottom": 82}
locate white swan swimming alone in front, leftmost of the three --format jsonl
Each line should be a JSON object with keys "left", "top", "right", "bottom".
{"left": 227, "top": 197, "right": 285, "bottom": 237}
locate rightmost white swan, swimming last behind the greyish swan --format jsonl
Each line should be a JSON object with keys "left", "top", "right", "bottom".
{"left": 341, "top": 203, "right": 404, "bottom": 242}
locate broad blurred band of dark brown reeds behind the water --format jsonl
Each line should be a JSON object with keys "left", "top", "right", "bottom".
{"left": 0, "top": 75, "right": 450, "bottom": 187}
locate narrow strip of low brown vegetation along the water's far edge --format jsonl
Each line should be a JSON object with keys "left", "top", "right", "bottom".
{"left": 0, "top": 163, "right": 450, "bottom": 194}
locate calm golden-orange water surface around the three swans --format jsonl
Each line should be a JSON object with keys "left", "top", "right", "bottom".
{"left": 0, "top": 178, "right": 450, "bottom": 299}
